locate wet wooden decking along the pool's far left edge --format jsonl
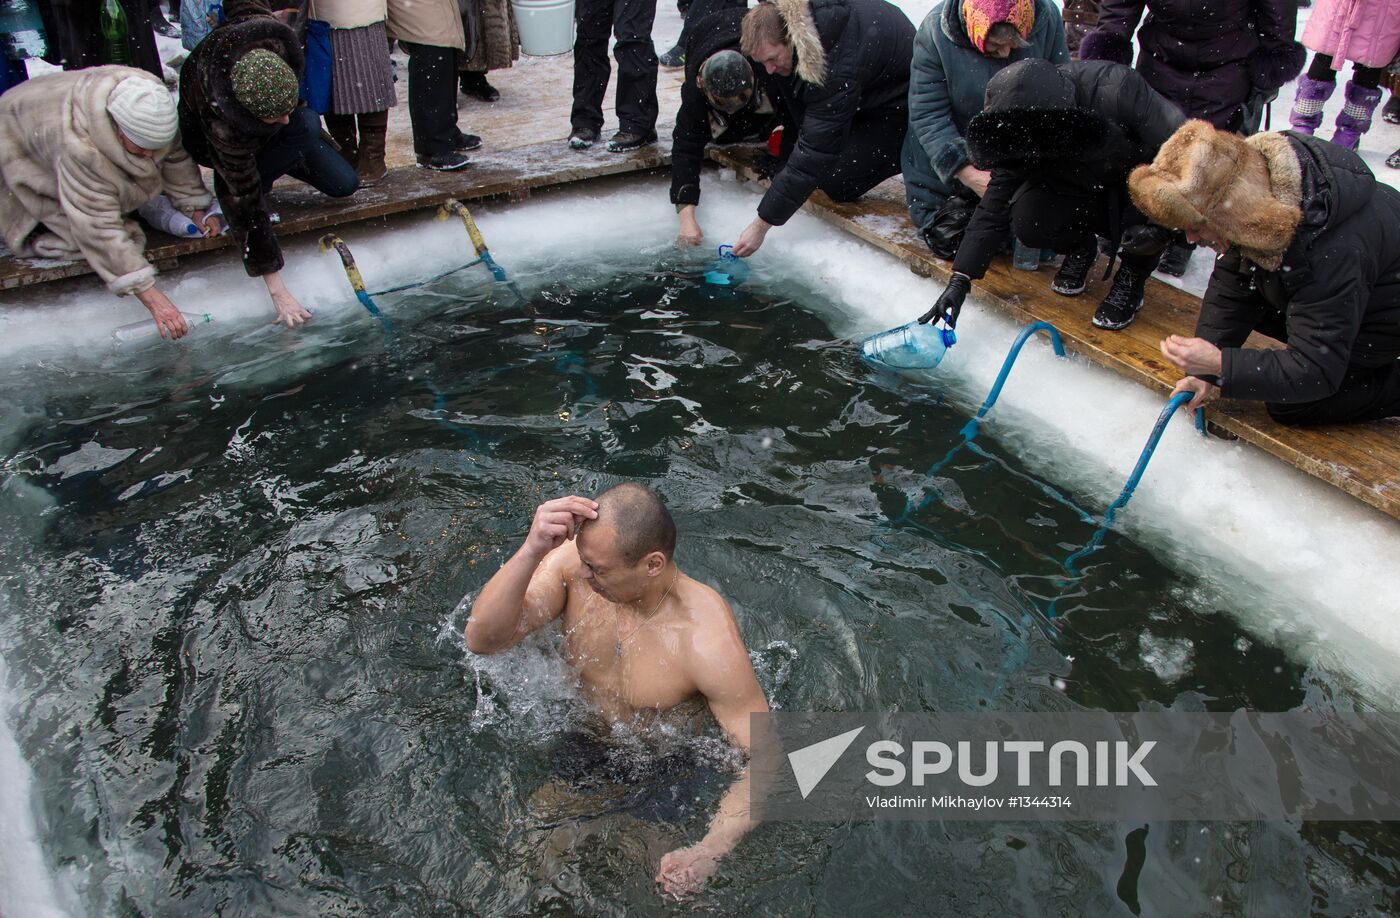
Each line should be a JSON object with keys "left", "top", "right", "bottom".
{"left": 0, "top": 132, "right": 671, "bottom": 290}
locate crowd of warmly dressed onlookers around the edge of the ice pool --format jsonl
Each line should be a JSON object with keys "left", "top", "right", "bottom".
{"left": 0, "top": 0, "right": 1400, "bottom": 424}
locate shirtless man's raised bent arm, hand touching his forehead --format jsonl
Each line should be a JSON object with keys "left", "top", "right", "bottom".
{"left": 465, "top": 495, "right": 598, "bottom": 654}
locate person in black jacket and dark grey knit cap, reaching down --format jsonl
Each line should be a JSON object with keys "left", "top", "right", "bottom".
{"left": 671, "top": 3, "right": 797, "bottom": 245}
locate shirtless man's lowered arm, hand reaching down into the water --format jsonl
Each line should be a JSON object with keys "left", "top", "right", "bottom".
{"left": 657, "top": 609, "right": 769, "bottom": 898}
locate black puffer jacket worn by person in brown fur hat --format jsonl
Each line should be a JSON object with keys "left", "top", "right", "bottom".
{"left": 1196, "top": 133, "right": 1400, "bottom": 403}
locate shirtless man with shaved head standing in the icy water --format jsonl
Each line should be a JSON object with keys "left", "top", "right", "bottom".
{"left": 466, "top": 483, "right": 769, "bottom": 897}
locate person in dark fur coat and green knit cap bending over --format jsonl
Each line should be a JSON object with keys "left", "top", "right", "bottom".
{"left": 179, "top": 0, "right": 360, "bottom": 327}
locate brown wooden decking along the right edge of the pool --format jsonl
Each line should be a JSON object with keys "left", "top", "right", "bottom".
{"left": 708, "top": 147, "right": 1400, "bottom": 519}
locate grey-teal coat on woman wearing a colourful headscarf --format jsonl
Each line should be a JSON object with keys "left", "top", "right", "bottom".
{"left": 903, "top": 0, "right": 1070, "bottom": 228}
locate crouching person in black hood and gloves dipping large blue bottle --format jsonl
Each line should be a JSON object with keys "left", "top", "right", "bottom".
{"left": 920, "top": 59, "right": 1186, "bottom": 329}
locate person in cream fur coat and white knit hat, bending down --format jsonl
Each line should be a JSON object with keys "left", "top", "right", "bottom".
{"left": 0, "top": 66, "right": 218, "bottom": 337}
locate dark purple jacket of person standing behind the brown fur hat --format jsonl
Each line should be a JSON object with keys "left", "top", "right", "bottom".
{"left": 1079, "top": 0, "right": 1306, "bottom": 130}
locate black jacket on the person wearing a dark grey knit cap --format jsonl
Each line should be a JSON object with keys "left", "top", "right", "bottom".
{"left": 671, "top": 7, "right": 794, "bottom": 204}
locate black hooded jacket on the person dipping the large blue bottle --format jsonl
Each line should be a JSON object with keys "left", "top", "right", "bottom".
{"left": 953, "top": 59, "right": 1186, "bottom": 278}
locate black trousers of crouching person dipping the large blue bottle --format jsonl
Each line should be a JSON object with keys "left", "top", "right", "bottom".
{"left": 1011, "top": 183, "right": 1162, "bottom": 274}
